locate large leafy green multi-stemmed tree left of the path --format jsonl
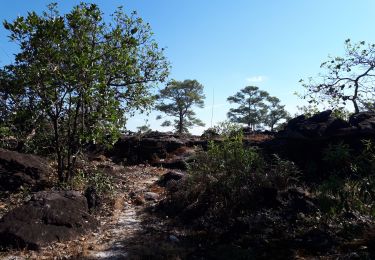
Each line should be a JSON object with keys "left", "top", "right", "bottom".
{"left": 0, "top": 3, "right": 169, "bottom": 181}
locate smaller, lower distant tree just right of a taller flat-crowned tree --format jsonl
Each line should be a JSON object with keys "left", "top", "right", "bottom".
{"left": 265, "top": 96, "right": 290, "bottom": 131}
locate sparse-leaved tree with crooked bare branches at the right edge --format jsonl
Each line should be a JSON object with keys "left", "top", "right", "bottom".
{"left": 300, "top": 39, "right": 375, "bottom": 113}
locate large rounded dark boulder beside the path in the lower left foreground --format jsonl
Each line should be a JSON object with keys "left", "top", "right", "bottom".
{"left": 0, "top": 191, "right": 98, "bottom": 250}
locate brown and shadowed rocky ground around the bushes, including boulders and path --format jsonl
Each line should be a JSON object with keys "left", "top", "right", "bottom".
{"left": 0, "top": 111, "right": 375, "bottom": 260}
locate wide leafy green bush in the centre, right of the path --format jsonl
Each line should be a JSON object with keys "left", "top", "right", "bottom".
{"left": 167, "top": 134, "right": 299, "bottom": 221}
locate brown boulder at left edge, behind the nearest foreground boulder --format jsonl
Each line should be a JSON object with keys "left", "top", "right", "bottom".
{"left": 0, "top": 149, "right": 52, "bottom": 191}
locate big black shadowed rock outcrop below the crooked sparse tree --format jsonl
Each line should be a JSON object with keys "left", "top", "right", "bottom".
{"left": 262, "top": 110, "right": 375, "bottom": 175}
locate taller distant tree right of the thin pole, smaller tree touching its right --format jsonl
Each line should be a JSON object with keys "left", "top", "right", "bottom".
{"left": 227, "top": 86, "right": 269, "bottom": 130}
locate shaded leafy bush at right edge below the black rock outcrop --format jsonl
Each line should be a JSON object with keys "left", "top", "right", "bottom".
{"left": 316, "top": 140, "right": 375, "bottom": 216}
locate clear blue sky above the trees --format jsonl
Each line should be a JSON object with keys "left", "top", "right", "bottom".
{"left": 0, "top": 0, "right": 375, "bottom": 133}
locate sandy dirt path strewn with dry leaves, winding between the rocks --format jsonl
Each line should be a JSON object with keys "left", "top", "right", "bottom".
{"left": 0, "top": 165, "right": 172, "bottom": 260}
